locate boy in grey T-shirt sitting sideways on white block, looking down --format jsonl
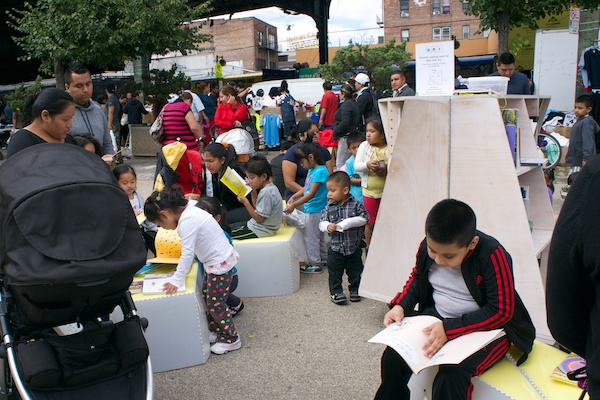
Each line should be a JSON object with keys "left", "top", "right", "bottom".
{"left": 231, "top": 156, "right": 283, "bottom": 240}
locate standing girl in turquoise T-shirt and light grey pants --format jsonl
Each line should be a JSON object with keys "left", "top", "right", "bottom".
{"left": 285, "top": 133, "right": 329, "bottom": 274}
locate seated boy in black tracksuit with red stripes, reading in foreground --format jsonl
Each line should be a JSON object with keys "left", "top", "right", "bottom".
{"left": 375, "top": 199, "right": 535, "bottom": 400}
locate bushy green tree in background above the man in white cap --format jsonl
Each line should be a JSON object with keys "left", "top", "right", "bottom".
{"left": 320, "top": 39, "right": 410, "bottom": 91}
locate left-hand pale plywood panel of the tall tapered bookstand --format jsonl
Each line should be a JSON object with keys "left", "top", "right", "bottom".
{"left": 360, "top": 97, "right": 450, "bottom": 302}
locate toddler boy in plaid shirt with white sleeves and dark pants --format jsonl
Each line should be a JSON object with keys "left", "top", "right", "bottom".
{"left": 319, "top": 171, "right": 369, "bottom": 304}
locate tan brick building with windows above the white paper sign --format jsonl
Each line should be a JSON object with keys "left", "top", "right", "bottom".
{"left": 383, "top": 0, "right": 487, "bottom": 43}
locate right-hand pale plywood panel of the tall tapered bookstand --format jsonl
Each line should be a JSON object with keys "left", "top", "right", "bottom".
{"left": 450, "top": 97, "right": 550, "bottom": 339}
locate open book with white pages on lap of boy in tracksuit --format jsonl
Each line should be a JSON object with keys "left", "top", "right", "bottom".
{"left": 369, "top": 315, "right": 504, "bottom": 374}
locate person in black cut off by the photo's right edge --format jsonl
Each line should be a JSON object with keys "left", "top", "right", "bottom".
{"left": 546, "top": 157, "right": 600, "bottom": 399}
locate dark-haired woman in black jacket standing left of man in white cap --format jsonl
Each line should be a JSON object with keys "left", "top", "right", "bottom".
{"left": 333, "top": 84, "right": 360, "bottom": 170}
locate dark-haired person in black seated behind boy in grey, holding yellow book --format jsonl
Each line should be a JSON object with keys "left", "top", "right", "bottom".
{"left": 196, "top": 143, "right": 251, "bottom": 223}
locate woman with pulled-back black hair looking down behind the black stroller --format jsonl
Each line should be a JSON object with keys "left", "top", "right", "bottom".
{"left": 7, "top": 88, "right": 77, "bottom": 157}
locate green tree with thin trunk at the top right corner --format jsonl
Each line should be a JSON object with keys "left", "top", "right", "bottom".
{"left": 461, "top": 0, "right": 598, "bottom": 53}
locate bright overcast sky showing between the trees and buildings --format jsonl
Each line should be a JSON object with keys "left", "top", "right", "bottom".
{"left": 220, "top": 0, "right": 383, "bottom": 51}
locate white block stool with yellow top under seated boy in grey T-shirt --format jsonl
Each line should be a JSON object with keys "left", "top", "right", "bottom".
{"left": 233, "top": 226, "right": 306, "bottom": 297}
